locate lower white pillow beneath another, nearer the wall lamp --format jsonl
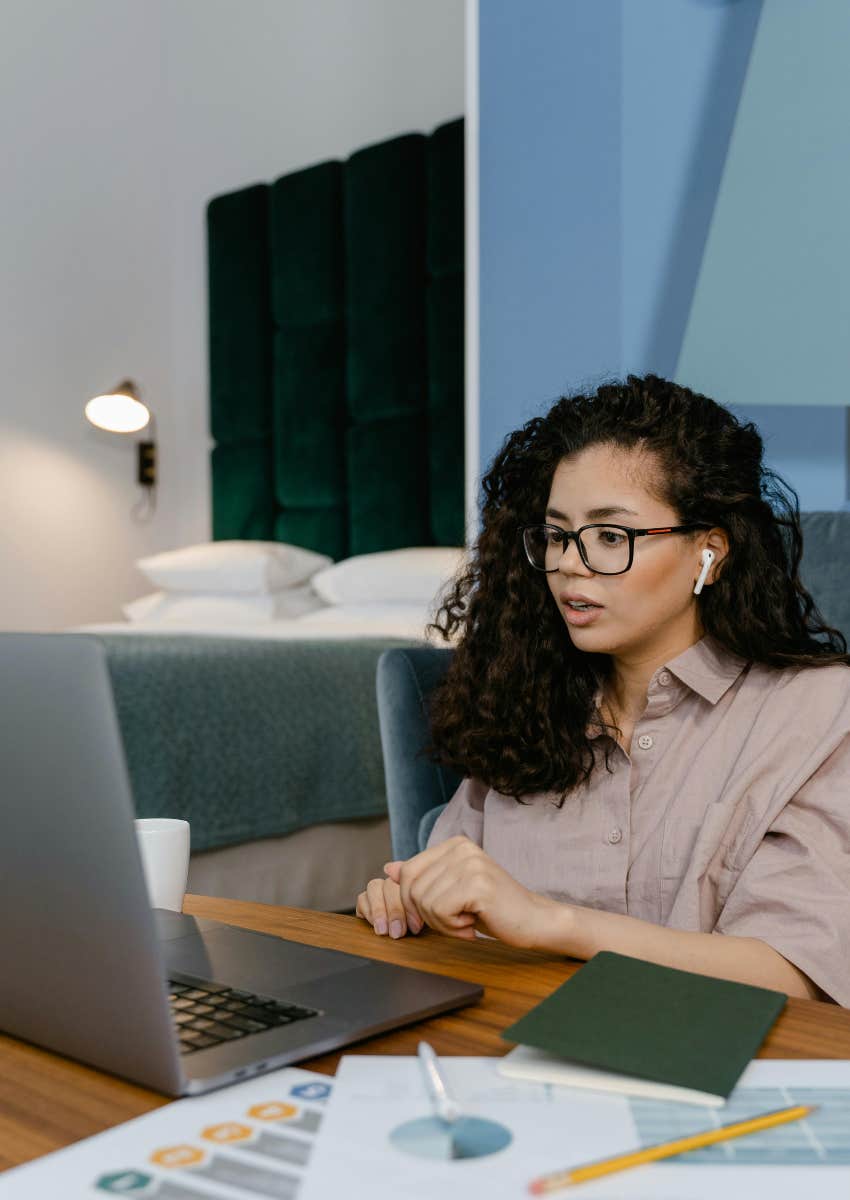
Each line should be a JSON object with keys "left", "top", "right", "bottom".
{"left": 124, "top": 583, "right": 325, "bottom": 628}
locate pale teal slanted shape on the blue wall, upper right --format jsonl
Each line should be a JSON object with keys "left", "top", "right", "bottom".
{"left": 677, "top": 0, "right": 850, "bottom": 406}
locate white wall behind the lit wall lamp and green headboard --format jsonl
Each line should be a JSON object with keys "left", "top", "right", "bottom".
{"left": 0, "top": 0, "right": 463, "bottom": 629}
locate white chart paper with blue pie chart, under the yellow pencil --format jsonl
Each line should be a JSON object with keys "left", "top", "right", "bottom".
{"left": 299, "top": 1055, "right": 850, "bottom": 1200}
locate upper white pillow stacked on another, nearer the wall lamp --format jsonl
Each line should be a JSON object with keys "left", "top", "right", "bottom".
{"left": 136, "top": 541, "right": 331, "bottom": 595}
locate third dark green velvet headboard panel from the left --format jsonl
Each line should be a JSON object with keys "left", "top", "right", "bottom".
{"left": 345, "top": 134, "right": 432, "bottom": 554}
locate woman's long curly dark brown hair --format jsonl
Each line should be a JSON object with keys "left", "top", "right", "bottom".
{"left": 430, "top": 376, "right": 850, "bottom": 802}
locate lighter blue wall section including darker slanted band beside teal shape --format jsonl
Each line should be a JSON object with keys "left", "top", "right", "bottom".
{"left": 621, "top": 0, "right": 761, "bottom": 378}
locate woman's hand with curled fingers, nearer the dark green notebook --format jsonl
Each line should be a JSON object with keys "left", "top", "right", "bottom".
{"left": 384, "top": 838, "right": 564, "bottom": 948}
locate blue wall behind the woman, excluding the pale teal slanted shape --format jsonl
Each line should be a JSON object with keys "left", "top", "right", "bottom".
{"left": 479, "top": 0, "right": 846, "bottom": 509}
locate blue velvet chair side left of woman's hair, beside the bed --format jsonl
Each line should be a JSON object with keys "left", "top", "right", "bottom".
{"left": 377, "top": 646, "right": 460, "bottom": 858}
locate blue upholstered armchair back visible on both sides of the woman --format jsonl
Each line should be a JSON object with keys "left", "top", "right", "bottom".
{"left": 377, "top": 512, "right": 850, "bottom": 858}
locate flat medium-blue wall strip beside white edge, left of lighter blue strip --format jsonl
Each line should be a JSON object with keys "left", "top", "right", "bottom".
{"left": 479, "top": 0, "right": 622, "bottom": 477}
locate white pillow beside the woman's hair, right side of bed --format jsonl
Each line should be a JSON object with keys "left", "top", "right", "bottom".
{"left": 311, "top": 546, "right": 466, "bottom": 605}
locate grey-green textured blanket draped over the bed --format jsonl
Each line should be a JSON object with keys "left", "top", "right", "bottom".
{"left": 96, "top": 634, "right": 409, "bottom": 851}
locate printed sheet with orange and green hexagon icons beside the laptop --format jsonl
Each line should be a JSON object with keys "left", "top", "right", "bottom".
{"left": 0, "top": 1067, "right": 334, "bottom": 1200}
